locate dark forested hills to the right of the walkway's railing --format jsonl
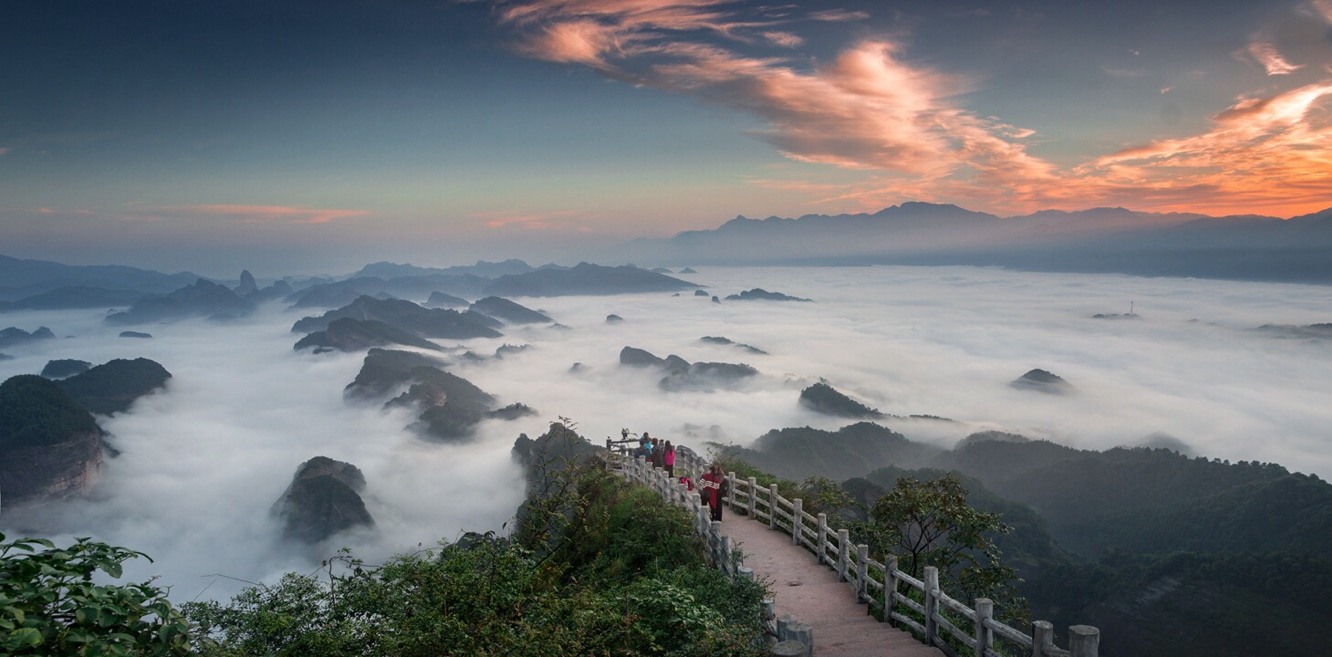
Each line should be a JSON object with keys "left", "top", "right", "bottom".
{"left": 723, "top": 422, "right": 1332, "bottom": 657}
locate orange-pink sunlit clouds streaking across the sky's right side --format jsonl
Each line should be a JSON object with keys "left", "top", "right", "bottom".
{"left": 497, "top": 0, "right": 1332, "bottom": 216}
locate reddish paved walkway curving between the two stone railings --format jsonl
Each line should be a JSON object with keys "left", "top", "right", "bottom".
{"left": 722, "top": 509, "right": 943, "bottom": 657}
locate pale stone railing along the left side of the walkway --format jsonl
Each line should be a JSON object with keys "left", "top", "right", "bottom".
{"left": 606, "top": 438, "right": 814, "bottom": 657}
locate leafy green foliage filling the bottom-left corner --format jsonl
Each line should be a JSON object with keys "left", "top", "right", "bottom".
{"left": 0, "top": 534, "right": 192, "bottom": 656}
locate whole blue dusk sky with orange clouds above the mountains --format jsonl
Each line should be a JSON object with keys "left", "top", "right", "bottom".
{"left": 0, "top": 0, "right": 1332, "bottom": 276}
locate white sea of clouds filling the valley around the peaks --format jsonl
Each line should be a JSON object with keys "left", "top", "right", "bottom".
{"left": 0, "top": 267, "right": 1332, "bottom": 600}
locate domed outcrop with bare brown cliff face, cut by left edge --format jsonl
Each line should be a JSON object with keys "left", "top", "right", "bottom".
{"left": 0, "top": 374, "right": 103, "bottom": 506}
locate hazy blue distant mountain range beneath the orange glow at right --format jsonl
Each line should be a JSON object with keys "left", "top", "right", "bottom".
{"left": 622, "top": 203, "right": 1332, "bottom": 283}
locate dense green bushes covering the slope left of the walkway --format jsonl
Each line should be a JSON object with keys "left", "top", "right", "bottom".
{"left": 185, "top": 466, "right": 766, "bottom": 657}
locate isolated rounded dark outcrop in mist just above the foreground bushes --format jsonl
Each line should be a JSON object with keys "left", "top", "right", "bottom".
{"left": 273, "top": 456, "right": 374, "bottom": 544}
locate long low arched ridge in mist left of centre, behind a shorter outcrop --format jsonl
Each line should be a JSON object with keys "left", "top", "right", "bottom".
{"left": 292, "top": 296, "right": 500, "bottom": 338}
